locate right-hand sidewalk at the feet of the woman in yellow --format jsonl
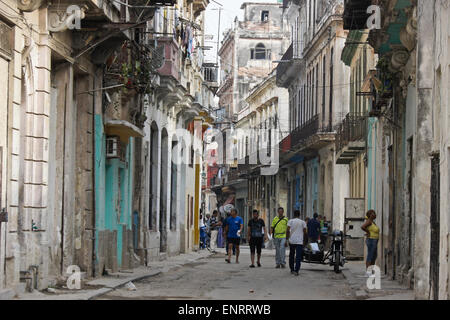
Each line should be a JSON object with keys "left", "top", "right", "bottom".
{"left": 342, "top": 261, "right": 414, "bottom": 300}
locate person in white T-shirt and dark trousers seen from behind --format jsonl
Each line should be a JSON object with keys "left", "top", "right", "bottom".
{"left": 286, "top": 210, "right": 307, "bottom": 276}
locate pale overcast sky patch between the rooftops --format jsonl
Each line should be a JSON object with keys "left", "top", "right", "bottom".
{"left": 205, "top": 0, "right": 277, "bottom": 62}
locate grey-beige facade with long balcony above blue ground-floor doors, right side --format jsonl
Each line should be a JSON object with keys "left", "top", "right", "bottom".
{"left": 277, "top": 1, "right": 350, "bottom": 229}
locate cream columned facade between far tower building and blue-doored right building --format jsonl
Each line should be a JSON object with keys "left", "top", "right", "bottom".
{"left": 236, "top": 72, "right": 289, "bottom": 236}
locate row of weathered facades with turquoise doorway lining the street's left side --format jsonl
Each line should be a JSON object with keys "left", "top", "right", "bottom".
{"left": 0, "top": 0, "right": 217, "bottom": 292}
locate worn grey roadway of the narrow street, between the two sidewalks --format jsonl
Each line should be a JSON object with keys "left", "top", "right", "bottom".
{"left": 98, "top": 247, "right": 354, "bottom": 300}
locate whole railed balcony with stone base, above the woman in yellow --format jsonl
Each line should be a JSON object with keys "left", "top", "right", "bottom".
{"left": 335, "top": 113, "right": 367, "bottom": 164}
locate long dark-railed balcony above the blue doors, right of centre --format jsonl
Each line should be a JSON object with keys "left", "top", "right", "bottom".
{"left": 281, "top": 114, "right": 335, "bottom": 156}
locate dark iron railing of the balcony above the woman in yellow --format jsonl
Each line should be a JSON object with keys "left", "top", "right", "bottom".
{"left": 335, "top": 113, "right": 367, "bottom": 153}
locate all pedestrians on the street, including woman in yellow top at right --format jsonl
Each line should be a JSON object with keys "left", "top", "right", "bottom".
{"left": 200, "top": 207, "right": 380, "bottom": 276}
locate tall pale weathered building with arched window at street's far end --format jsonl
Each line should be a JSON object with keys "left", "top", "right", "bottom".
{"left": 215, "top": 2, "right": 289, "bottom": 215}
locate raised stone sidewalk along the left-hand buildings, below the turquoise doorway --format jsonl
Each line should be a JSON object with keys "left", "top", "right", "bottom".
{"left": 14, "top": 250, "right": 211, "bottom": 300}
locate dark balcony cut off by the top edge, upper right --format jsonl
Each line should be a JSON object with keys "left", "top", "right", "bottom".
{"left": 344, "top": 0, "right": 372, "bottom": 30}
